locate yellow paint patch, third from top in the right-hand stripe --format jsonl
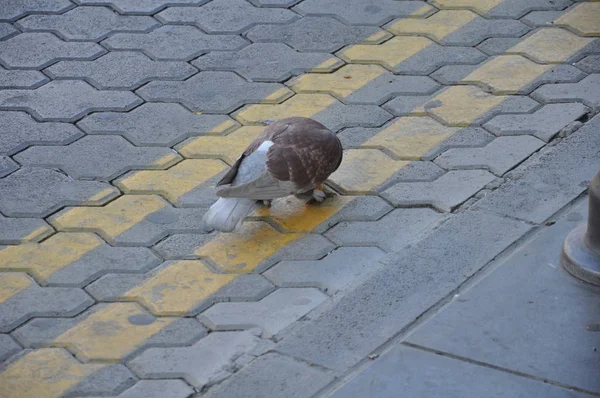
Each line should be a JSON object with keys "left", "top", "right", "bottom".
{"left": 461, "top": 55, "right": 551, "bottom": 94}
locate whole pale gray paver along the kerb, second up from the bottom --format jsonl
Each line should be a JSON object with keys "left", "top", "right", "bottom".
{"left": 203, "top": 288, "right": 327, "bottom": 338}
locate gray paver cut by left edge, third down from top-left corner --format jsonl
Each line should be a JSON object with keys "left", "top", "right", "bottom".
{"left": 0, "top": 32, "right": 106, "bottom": 69}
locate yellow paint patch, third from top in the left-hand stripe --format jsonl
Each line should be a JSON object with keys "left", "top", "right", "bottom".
{"left": 340, "top": 36, "right": 433, "bottom": 69}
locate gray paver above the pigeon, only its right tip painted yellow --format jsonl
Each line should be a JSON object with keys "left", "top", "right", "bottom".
{"left": 192, "top": 43, "right": 342, "bottom": 82}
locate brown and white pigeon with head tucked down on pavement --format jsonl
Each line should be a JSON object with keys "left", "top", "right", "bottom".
{"left": 203, "top": 117, "right": 342, "bottom": 232}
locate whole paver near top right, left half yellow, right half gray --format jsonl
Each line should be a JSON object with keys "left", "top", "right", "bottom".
{"left": 386, "top": 10, "right": 530, "bottom": 46}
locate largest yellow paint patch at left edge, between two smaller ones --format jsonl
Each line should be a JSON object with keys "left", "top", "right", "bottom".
{"left": 0, "top": 233, "right": 103, "bottom": 283}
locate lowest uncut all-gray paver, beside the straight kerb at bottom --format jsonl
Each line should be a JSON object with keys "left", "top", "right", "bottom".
{"left": 128, "top": 330, "right": 273, "bottom": 389}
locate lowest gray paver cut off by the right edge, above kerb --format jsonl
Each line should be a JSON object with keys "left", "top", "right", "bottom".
{"left": 531, "top": 73, "right": 600, "bottom": 108}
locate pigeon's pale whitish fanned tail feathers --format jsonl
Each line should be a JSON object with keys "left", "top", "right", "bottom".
{"left": 203, "top": 198, "right": 258, "bottom": 232}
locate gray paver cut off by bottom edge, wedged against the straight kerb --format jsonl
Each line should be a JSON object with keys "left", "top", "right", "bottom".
{"left": 206, "top": 353, "right": 333, "bottom": 398}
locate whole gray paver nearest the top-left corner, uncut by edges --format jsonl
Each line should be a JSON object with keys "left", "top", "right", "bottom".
{"left": 17, "top": 7, "right": 160, "bottom": 41}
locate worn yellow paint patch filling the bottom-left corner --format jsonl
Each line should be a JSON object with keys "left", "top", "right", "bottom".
{"left": 0, "top": 348, "right": 105, "bottom": 398}
